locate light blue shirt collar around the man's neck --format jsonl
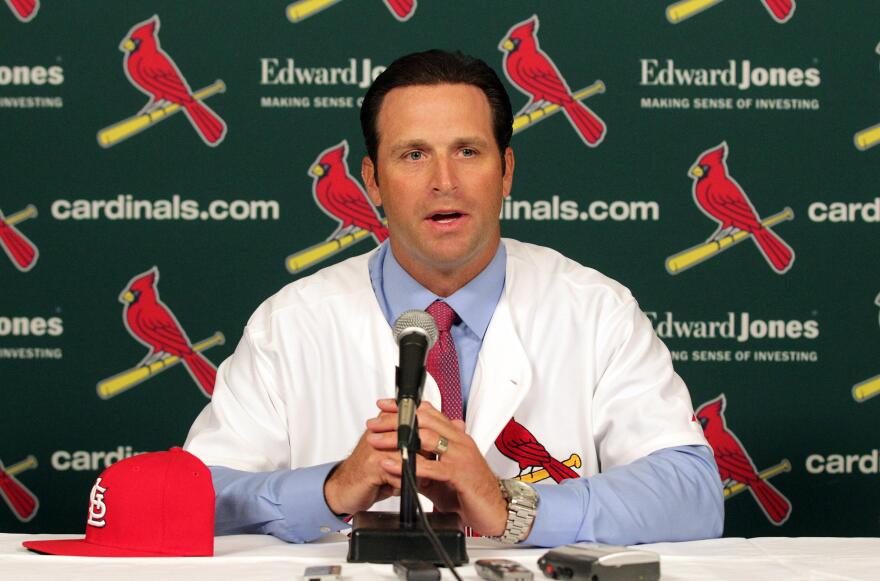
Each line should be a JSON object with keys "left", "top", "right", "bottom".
{"left": 382, "top": 242, "right": 507, "bottom": 340}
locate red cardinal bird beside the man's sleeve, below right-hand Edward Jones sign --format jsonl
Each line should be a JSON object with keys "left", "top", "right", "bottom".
{"left": 697, "top": 394, "right": 791, "bottom": 525}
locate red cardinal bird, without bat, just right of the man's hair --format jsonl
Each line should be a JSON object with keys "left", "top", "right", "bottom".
{"left": 498, "top": 15, "right": 605, "bottom": 147}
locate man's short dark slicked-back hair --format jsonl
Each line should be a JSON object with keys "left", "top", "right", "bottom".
{"left": 361, "top": 49, "right": 513, "bottom": 171}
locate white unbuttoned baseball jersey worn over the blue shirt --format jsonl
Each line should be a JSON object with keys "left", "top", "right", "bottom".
{"left": 185, "top": 239, "right": 708, "bottom": 509}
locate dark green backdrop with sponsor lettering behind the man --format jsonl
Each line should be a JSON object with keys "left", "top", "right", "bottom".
{"left": 0, "top": 0, "right": 880, "bottom": 536}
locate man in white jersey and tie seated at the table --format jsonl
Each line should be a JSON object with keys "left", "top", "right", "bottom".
{"left": 186, "top": 51, "right": 723, "bottom": 546}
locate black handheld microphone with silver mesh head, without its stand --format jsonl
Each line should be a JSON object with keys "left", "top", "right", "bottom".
{"left": 394, "top": 309, "right": 439, "bottom": 450}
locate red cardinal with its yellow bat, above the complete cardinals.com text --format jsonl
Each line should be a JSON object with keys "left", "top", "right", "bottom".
{"left": 98, "top": 16, "right": 226, "bottom": 147}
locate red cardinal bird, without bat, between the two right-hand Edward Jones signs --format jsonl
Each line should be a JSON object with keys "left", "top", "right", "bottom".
{"left": 689, "top": 142, "right": 794, "bottom": 274}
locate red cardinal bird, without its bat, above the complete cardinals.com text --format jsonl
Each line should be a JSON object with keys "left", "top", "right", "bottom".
{"left": 119, "top": 16, "right": 226, "bottom": 146}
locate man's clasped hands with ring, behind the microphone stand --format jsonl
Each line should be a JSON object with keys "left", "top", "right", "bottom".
{"left": 324, "top": 399, "right": 507, "bottom": 536}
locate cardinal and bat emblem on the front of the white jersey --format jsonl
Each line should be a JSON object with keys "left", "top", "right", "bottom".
{"left": 495, "top": 418, "right": 581, "bottom": 484}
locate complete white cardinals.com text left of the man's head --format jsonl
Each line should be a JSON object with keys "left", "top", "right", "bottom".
{"left": 51, "top": 194, "right": 281, "bottom": 221}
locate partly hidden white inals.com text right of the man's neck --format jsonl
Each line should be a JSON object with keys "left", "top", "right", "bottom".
{"left": 501, "top": 196, "right": 660, "bottom": 222}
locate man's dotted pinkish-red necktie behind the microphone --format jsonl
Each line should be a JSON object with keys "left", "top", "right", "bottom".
{"left": 425, "top": 301, "right": 464, "bottom": 420}
